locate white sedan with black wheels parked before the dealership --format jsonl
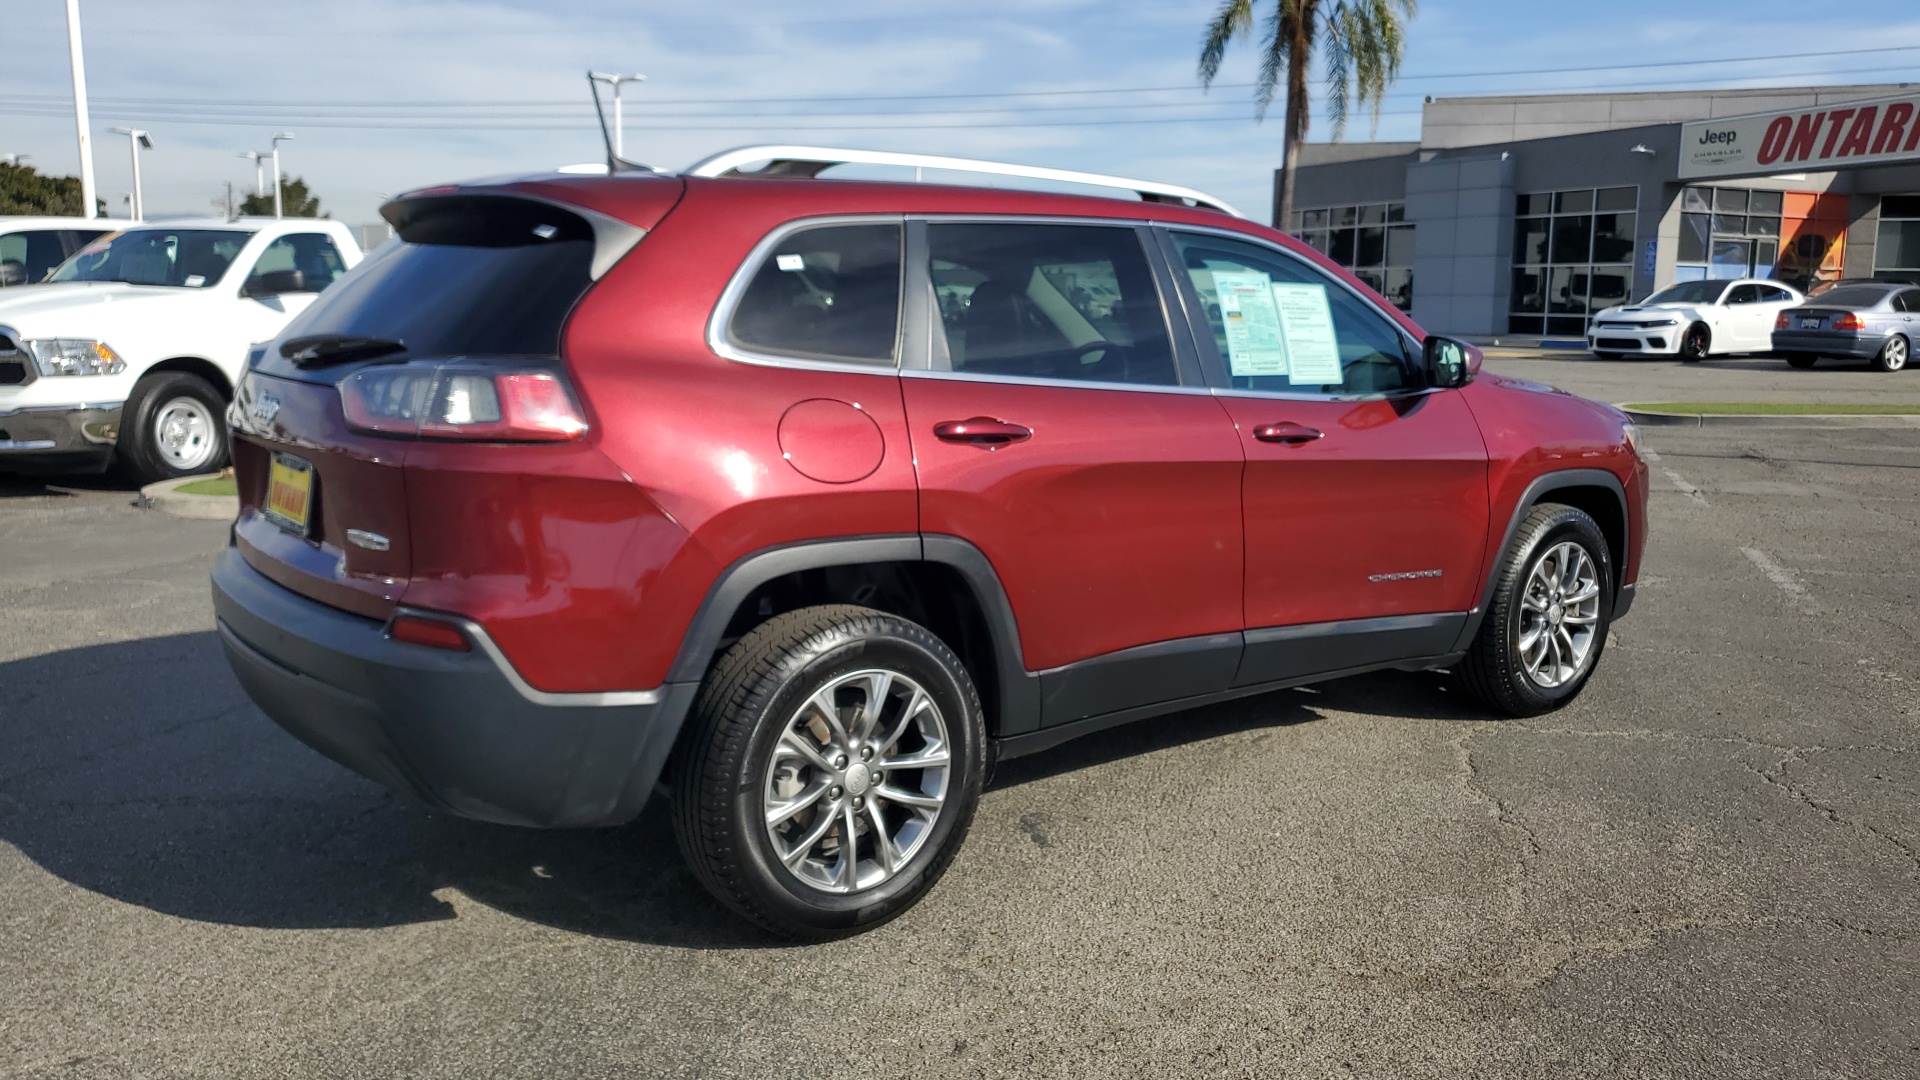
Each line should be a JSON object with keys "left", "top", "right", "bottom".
{"left": 1586, "top": 279, "right": 1805, "bottom": 363}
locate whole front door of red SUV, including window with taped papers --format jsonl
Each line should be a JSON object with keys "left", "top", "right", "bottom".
{"left": 1167, "top": 231, "right": 1488, "bottom": 664}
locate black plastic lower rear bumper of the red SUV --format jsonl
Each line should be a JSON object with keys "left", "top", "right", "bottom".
{"left": 213, "top": 548, "right": 699, "bottom": 826}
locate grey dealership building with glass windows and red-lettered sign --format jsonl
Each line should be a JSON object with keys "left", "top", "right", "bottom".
{"left": 1275, "top": 83, "right": 1920, "bottom": 336}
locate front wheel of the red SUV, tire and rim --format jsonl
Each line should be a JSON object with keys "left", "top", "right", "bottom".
{"left": 1453, "top": 503, "right": 1613, "bottom": 717}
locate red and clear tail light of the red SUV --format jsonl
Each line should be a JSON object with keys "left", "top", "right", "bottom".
{"left": 340, "top": 359, "right": 588, "bottom": 442}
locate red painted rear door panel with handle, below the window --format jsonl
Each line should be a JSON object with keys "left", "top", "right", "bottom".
{"left": 900, "top": 373, "right": 1242, "bottom": 672}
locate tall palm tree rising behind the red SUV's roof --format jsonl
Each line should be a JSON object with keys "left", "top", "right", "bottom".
{"left": 1200, "top": 0, "right": 1419, "bottom": 229}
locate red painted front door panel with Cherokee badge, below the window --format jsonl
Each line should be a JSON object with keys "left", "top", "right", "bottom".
{"left": 1221, "top": 390, "right": 1488, "bottom": 628}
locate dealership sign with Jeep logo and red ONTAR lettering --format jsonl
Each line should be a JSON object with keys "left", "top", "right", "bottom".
{"left": 1680, "top": 94, "right": 1920, "bottom": 181}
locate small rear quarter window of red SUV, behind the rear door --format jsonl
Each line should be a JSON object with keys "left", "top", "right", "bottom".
{"left": 728, "top": 223, "right": 902, "bottom": 367}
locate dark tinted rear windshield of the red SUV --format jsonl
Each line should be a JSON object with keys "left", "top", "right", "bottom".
{"left": 261, "top": 196, "right": 593, "bottom": 371}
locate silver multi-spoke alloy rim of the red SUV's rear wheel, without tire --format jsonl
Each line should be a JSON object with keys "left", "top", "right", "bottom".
{"left": 760, "top": 669, "right": 952, "bottom": 894}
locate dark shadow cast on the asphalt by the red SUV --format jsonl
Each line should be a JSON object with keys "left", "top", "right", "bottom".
{"left": 0, "top": 632, "right": 1476, "bottom": 949}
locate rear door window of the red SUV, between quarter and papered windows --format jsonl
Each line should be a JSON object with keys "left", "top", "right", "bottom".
{"left": 927, "top": 223, "right": 1179, "bottom": 386}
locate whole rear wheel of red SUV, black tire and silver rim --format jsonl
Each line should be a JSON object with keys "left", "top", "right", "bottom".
{"left": 672, "top": 605, "right": 987, "bottom": 940}
